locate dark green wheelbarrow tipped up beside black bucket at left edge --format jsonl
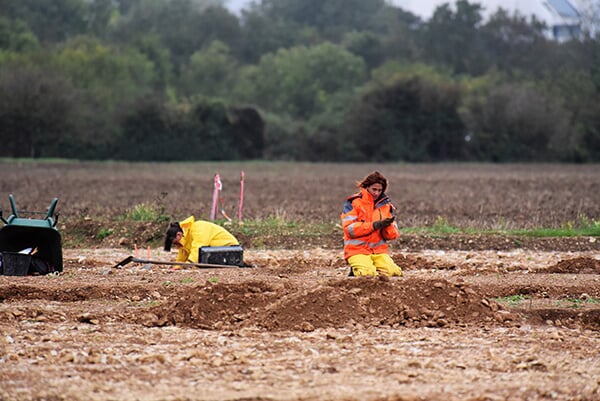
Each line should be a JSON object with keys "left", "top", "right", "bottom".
{"left": 0, "top": 194, "right": 63, "bottom": 276}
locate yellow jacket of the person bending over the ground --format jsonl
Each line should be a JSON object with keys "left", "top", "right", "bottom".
{"left": 175, "top": 216, "right": 239, "bottom": 263}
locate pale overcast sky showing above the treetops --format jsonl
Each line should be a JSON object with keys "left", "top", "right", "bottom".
{"left": 227, "top": 0, "right": 545, "bottom": 20}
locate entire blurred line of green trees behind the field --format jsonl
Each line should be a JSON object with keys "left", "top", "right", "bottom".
{"left": 0, "top": 0, "right": 600, "bottom": 162}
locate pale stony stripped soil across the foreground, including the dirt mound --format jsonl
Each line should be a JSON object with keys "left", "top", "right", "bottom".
{"left": 0, "top": 249, "right": 600, "bottom": 400}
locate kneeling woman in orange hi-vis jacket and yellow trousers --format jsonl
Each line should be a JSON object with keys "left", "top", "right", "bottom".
{"left": 341, "top": 171, "right": 402, "bottom": 276}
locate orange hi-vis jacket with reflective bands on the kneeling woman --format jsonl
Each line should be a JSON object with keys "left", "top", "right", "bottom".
{"left": 342, "top": 188, "right": 400, "bottom": 259}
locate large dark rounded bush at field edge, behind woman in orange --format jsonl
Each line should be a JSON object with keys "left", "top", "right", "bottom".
{"left": 343, "top": 77, "right": 465, "bottom": 161}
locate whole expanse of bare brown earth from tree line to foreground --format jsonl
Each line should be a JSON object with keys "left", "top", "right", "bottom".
{"left": 0, "top": 162, "right": 600, "bottom": 401}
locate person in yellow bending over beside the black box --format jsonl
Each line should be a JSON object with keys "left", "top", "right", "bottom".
{"left": 165, "top": 216, "right": 240, "bottom": 263}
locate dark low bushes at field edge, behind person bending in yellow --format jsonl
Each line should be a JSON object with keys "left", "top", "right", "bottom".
{"left": 114, "top": 98, "right": 264, "bottom": 161}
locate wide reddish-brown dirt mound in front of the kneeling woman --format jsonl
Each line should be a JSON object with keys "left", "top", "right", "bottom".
{"left": 146, "top": 277, "right": 514, "bottom": 332}
